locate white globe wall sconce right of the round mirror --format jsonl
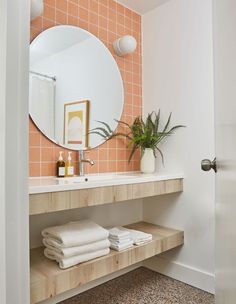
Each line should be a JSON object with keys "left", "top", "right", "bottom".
{"left": 113, "top": 35, "right": 137, "bottom": 56}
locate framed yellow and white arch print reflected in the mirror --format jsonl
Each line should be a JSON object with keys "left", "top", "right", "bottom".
{"left": 64, "top": 100, "right": 90, "bottom": 150}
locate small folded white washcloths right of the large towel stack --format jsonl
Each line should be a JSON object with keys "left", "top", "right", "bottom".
{"left": 108, "top": 226, "right": 152, "bottom": 251}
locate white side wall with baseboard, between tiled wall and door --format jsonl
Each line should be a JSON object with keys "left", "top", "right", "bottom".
{"left": 143, "top": 0, "right": 215, "bottom": 291}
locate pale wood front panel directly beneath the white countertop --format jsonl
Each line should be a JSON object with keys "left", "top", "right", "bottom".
{"left": 29, "top": 178, "right": 183, "bottom": 215}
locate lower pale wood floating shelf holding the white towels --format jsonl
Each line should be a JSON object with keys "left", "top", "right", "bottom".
{"left": 30, "top": 222, "right": 184, "bottom": 304}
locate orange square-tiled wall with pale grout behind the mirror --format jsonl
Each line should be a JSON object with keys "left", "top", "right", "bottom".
{"left": 29, "top": 0, "right": 142, "bottom": 176}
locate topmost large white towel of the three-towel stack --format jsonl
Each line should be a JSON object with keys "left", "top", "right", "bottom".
{"left": 42, "top": 220, "right": 109, "bottom": 248}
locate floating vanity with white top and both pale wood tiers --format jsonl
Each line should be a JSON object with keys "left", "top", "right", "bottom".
{"left": 29, "top": 175, "right": 184, "bottom": 304}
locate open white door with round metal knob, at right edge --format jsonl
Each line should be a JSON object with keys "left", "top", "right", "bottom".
{"left": 213, "top": 0, "right": 236, "bottom": 304}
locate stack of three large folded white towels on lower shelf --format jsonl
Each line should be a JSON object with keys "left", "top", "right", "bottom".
{"left": 42, "top": 220, "right": 110, "bottom": 269}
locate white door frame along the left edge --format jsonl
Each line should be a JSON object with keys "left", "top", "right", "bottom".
{"left": 0, "top": 0, "right": 30, "bottom": 304}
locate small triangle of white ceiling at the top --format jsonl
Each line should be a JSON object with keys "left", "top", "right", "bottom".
{"left": 117, "top": 0, "right": 170, "bottom": 15}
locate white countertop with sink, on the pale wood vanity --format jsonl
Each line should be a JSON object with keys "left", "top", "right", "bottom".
{"left": 29, "top": 172, "right": 184, "bottom": 194}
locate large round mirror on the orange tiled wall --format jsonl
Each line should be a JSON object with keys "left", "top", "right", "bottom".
{"left": 30, "top": 25, "right": 124, "bottom": 150}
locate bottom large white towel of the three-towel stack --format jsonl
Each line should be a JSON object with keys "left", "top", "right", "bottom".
{"left": 44, "top": 248, "right": 110, "bottom": 269}
